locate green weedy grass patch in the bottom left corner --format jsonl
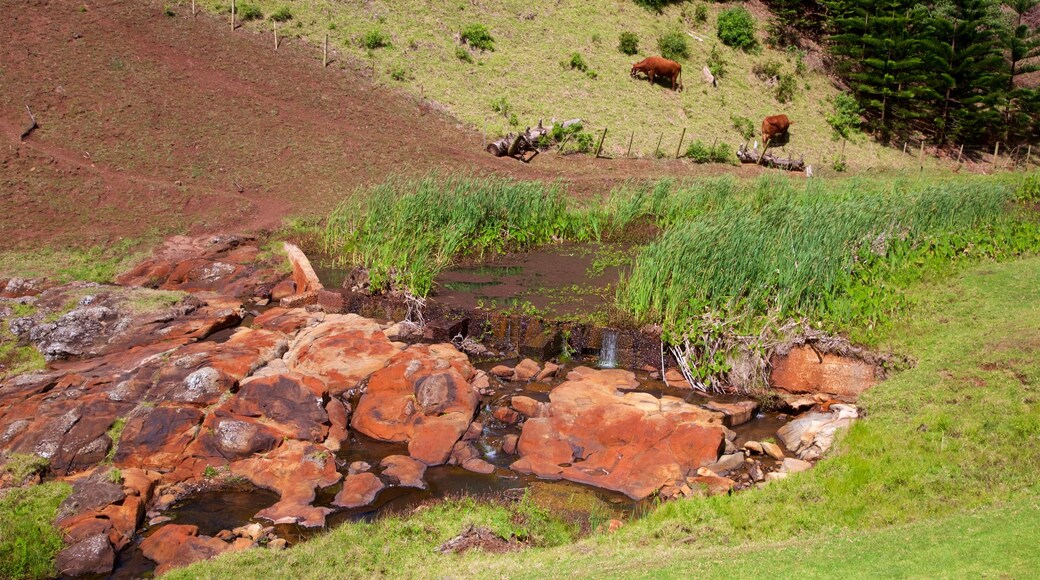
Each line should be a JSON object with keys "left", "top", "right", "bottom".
{"left": 0, "top": 481, "right": 72, "bottom": 578}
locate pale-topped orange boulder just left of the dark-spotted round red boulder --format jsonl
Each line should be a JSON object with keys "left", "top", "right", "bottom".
{"left": 286, "top": 314, "right": 398, "bottom": 395}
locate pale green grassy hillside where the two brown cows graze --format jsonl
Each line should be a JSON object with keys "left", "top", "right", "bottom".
{"left": 203, "top": 0, "right": 916, "bottom": 170}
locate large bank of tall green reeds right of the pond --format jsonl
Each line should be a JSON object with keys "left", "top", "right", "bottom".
{"left": 609, "top": 172, "right": 1040, "bottom": 334}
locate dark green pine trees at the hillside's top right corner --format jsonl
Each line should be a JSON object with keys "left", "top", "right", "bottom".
{"left": 769, "top": 0, "right": 1040, "bottom": 146}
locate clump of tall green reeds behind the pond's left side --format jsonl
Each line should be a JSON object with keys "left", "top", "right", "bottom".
{"left": 323, "top": 177, "right": 602, "bottom": 296}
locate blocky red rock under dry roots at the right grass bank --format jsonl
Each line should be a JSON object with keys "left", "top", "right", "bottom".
{"left": 770, "top": 346, "right": 877, "bottom": 400}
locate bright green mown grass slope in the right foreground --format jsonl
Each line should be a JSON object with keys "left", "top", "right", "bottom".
{"left": 168, "top": 258, "right": 1040, "bottom": 578}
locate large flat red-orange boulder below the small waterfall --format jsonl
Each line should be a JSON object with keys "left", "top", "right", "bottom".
{"left": 512, "top": 369, "right": 725, "bottom": 499}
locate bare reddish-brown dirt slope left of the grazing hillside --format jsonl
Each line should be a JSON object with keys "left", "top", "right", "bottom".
{"left": 0, "top": 0, "right": 756, "bottom": 247}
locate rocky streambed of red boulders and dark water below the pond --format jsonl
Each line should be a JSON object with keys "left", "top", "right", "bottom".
{"left": 0, "top": 237, "right": 873, "bottom": 576}
